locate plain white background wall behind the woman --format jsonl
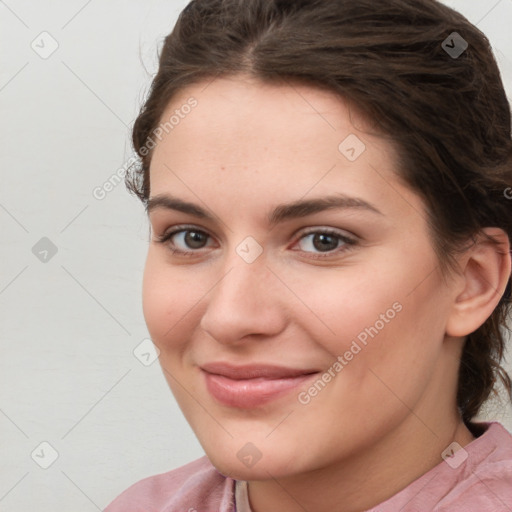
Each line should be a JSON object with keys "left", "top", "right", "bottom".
{"left": 0, "top": 0, "right": 512, "bottom": 512}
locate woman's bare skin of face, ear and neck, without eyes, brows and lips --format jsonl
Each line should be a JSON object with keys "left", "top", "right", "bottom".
{"left": 143, "top": 76, "right": 510, "bottom": 512}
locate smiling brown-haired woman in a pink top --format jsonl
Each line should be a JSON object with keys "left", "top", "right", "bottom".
{"left": 106, "top": 0, "right": 512, "bottom": 512}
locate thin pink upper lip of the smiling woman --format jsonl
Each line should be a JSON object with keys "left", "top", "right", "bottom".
{"left": 201, "top": 362, "right": 318, "bottom": 380}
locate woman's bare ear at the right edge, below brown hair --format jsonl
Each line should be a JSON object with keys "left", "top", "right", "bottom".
{"left": 446, "top": 228, "right": 511, "bottom": 337}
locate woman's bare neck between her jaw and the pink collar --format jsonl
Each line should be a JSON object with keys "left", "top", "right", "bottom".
{"left": 249, "top": 413, "right": 474, "bottom": 512}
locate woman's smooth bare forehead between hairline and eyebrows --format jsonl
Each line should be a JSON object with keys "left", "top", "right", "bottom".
{"left": 150, "top": 77, "right": 424, "bottom": 222}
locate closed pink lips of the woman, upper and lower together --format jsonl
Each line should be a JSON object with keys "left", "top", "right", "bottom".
{"left": 201, "top": 362, "right": 319, "bottom": 408}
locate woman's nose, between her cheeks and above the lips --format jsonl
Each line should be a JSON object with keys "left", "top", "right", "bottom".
{"left": 200, "top": 259, "right": 287, "bottom": 344}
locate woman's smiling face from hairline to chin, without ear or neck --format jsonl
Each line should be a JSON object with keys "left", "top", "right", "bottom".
{"left": 143, "top": 77, "right": 460, "bottom": 480}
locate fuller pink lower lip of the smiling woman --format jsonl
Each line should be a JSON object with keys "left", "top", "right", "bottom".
{"left": 203, "top": 371, "right": 318, "bottom": 409}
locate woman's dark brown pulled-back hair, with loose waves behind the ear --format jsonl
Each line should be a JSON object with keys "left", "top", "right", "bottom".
{"left": 126, "top": 0, "right": 512, "bottom": 424}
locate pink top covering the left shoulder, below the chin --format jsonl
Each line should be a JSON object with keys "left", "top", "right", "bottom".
{"left": 105, "top": 456, "right": 234, "bottom": 512}
